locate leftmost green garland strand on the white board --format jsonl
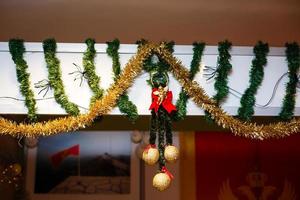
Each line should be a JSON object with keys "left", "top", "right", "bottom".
{"left": 9, "top": 39, "right": 37, "bottom": 122}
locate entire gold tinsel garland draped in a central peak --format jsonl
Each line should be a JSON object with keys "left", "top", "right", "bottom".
{"left": 0, "top": 43, "right": 300, "bottom": 139}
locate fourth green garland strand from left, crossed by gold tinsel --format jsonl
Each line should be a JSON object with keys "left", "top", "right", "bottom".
{"left": 106, "top": 39, "right": 139, "bottom": 122}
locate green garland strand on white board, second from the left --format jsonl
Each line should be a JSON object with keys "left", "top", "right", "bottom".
{"left": 43, "top": 39, "right": 79, "bottom": 115}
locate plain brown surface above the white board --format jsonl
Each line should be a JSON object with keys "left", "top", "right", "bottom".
{"left": 0, "top": 0, "right": 300, "bottom": 46}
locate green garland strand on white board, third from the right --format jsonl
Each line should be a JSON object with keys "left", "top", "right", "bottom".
{"left": 213, "top": 40, "right": 232, "bottom": 104}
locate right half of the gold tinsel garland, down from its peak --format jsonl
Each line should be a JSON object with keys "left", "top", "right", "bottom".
{"left": 155, "top": 42, "right": 300, "bottom": 140}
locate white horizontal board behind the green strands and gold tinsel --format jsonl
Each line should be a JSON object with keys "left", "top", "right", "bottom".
{"left": 0, "top": 42, "right": 300, "bottom": 116}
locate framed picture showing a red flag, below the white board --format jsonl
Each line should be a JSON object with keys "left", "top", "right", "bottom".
{"left": 26, "top": 131, "right": 140, "bottom": 200}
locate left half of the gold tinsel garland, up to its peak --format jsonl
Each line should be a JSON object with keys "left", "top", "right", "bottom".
{"left": 0, "top": 44, "right": 154, "bottom": 137}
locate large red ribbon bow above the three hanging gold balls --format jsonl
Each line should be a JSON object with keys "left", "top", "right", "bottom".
{"left": 149, "top": 88, "right": 176, "bottom": 113}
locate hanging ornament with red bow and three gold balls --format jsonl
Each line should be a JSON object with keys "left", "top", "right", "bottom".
{"left": 143, "top": 69, "right": 179, "bottom": 191}
